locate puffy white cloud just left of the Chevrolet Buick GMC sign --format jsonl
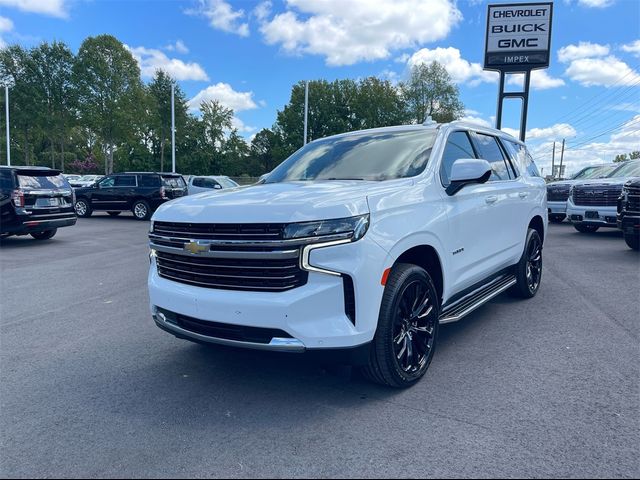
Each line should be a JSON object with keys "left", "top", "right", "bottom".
{"left": 407, "top": 47, "right": 498, "bottom": 86}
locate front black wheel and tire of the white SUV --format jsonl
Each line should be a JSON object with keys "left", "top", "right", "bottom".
{"left": 362, "top": 263, "right": 440, "bottom": 388}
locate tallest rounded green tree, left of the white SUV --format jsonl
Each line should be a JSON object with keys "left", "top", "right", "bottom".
{"left": 73, "top": 35, "right": 142, "bottom": 173}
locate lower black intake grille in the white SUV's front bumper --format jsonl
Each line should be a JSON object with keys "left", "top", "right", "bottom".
{"left": 158, "top": 308, "right": 293, "bottom": 345}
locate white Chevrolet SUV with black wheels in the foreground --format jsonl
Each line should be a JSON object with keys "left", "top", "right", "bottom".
{"left": 149, "top": 122, "right": 547, "bottom": 387}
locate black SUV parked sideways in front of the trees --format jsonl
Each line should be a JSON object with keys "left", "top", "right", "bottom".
{"left": 75, "top": 172, "right": 187, "bottom": 220}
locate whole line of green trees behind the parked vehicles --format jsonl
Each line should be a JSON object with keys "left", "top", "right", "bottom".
{"left": 0, "top": 35, "right": 464, "bottom": 176}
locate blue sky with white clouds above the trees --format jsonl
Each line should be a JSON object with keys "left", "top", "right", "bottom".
{"left": 0, "top": 0, "right": 640, "bottom": 173}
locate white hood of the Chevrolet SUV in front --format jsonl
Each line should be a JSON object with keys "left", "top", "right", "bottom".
{"left": 153, "top": 179, "right": 413, "bottom": 223}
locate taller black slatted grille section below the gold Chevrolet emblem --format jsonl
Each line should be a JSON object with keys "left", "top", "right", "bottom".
{"left": 156, "top": 251, "right": 308, "bottom": 292}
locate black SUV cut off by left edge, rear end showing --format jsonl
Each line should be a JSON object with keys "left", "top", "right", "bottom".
{"left": 0, "top": 166, "right": 76, "bottom": 240}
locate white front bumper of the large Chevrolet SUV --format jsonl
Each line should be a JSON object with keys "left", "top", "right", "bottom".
{"left": 148, "top": 236, "right": 388, "bottom": 351}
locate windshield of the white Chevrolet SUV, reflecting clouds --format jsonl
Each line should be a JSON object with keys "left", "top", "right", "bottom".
{"left": 265, "top": 129, "right": 436, "bottom": 183}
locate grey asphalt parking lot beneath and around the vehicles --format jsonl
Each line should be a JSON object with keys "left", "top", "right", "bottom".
{"left": 0, "top": 214, "right": 640, "bottom": 478}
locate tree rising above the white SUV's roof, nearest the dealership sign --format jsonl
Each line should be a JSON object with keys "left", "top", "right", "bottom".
{"left": 400, "top": 62, "right": 464, "bottom": 123}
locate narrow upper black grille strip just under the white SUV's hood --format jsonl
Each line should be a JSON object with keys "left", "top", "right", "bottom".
{"left": 153, "top": 222, "right": 284, "bottom": 241}
